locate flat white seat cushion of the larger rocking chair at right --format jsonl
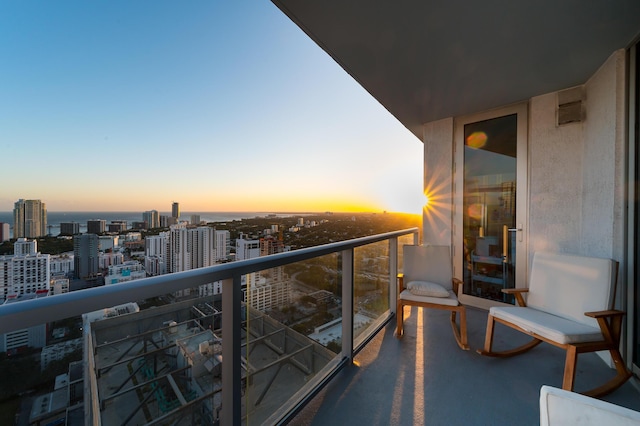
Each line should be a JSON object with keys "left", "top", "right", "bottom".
{"left": 489, "top": 306, "right": 603, "bottom": 344}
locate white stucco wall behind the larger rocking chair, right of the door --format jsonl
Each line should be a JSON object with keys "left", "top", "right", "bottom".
{"left": 528, "top": 51, "right": 625, "bottom": 260}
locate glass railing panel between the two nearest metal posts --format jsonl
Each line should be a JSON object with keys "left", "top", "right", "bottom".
{"left": 241, "top": 254, "right": 342, "bottom": 424}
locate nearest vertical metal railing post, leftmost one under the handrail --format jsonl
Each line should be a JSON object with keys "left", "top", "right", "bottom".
{"left": 220, "top": 274, "right": 242, "bottom": 425}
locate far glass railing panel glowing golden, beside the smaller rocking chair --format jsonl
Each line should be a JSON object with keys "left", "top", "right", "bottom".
{"left": 353, "top": 240, "right": 390, "bottom": 347}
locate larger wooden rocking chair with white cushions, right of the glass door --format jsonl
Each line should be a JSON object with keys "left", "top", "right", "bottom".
{"left": 478, "top": 253, "right": 631, "bottom": 396}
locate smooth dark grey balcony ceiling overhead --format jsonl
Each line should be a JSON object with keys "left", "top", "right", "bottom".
{"left": 273, "top": 0, "right": 640, "bottom": 139}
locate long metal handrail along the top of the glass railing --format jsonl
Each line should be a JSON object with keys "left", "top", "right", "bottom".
{"left": 0, "top": 228, "right": 418, "bottom": 334}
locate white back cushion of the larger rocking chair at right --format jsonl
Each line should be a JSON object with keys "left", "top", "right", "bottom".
{"left": 527, "top": 252, "right": 617, "bottom": 326}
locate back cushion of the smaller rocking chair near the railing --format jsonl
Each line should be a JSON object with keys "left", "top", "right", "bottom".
{"left": 402, "top": 245, "right": 453, "bottom": 290}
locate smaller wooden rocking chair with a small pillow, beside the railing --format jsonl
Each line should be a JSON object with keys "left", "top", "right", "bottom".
{"left": 396, "top": 245, "right": 469, "bottom": 350}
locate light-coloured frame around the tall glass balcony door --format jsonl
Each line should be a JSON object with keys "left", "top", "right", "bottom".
{"left": 452, "top": 102, "right": 529, "bottom": 309}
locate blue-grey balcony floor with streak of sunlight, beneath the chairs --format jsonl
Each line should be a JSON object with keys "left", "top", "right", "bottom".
{"left": 290, "top": 308, "right": 640, "bottom": 426}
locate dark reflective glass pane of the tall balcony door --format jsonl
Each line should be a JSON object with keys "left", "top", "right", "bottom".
{"left": 462, "top": 114, "right": 522, "bottom": 303}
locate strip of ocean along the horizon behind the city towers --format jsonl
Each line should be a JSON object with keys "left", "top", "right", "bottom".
{"left": 0, "top": 211, "right": 317, "bottom": 238}
